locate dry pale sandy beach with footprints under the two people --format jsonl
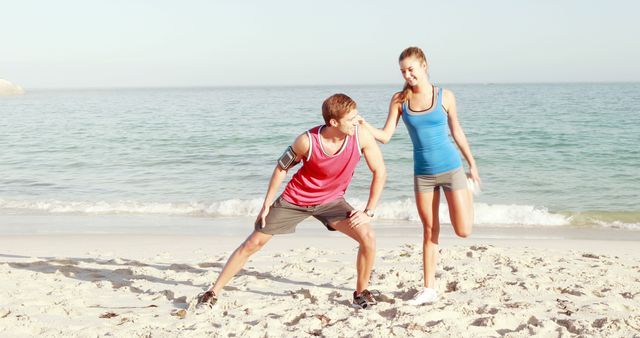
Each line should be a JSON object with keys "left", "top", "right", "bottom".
{"left": 0, "top": 229, "right": 640, "bottom": 337}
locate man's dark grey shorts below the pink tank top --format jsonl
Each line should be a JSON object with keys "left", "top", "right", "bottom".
{"left": 254, "top": 196, "right": 354, "bottom": 235}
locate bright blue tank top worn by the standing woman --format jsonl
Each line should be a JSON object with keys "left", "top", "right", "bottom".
{"left": 402, "top": 88, "right": 462, "bottom": 175}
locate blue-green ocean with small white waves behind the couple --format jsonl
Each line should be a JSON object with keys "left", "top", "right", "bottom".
{"left": 0, "top": 83, "right": 640, "bottom": 232}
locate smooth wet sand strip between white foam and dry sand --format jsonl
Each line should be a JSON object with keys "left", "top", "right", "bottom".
{"left": 0, "top": 213, "right": 640, "bottom": 241}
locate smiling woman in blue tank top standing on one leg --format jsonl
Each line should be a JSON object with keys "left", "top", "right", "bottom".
{"left": 360, "top": 47, "right": 480, "bottom": 305}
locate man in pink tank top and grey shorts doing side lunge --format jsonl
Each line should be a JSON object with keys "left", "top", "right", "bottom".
{"left": 198, "top": 94, "right": 386, "bottom": 308}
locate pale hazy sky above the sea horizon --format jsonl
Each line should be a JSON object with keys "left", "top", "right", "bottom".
{"left": 0, "top": 0, "right": 640, "bottom": 90}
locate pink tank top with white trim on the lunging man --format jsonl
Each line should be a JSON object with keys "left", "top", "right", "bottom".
{"left": 282, "top": 126, "right": 362, "bottom": 206}
